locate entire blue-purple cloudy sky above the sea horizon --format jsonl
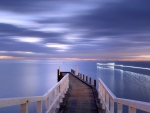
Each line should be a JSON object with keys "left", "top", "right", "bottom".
{"left": 0, "top": 0, "right": 150, "bottom": 61}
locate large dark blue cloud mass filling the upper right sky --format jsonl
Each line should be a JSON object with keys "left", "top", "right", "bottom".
{"left": 69, "top": 0, "right": 150, "bottom": 36}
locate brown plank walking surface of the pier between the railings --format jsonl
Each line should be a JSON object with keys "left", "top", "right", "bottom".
{"left": 63, "top": 74, "right": 98, "bottom": 113}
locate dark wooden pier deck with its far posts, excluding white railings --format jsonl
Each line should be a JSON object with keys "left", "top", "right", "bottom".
{"left": 56, "top": 70, "right": 105, "bottom": 113}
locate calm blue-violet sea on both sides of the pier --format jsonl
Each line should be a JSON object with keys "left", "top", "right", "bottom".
{"left": 0, "top": 60, "right": 150, "bottom": 113}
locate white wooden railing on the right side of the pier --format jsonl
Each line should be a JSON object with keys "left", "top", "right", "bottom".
{"left": 98, "top": 78, "right": 150, "bottom": 113}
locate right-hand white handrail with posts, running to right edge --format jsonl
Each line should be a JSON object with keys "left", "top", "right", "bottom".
{"left": 98, "top": 78, "right": 150, "bottom": 113}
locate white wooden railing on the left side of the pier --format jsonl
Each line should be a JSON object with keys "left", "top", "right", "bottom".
{"left": 0, "top": 74, "right": 69, "bottom": 113}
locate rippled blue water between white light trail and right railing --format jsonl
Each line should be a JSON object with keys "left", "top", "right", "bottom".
{"left": 97, "top": 64, "right": 150, "bottom": 102}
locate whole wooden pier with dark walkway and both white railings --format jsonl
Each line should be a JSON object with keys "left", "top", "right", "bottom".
{"left": 0, "top": 68, "right": 150, "bottom": 113}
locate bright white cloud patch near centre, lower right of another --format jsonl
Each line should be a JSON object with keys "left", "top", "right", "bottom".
{"left": 46, "top": 43, "right": 70, "bottom": 50}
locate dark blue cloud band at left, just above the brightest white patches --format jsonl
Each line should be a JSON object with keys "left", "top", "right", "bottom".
{"left": 0, "top": 23, "right": 63, "bottom": 42}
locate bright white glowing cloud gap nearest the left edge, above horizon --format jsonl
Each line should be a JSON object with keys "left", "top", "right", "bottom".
{"left": 13, "top": 37, "right": 43, "bottom": 43}
